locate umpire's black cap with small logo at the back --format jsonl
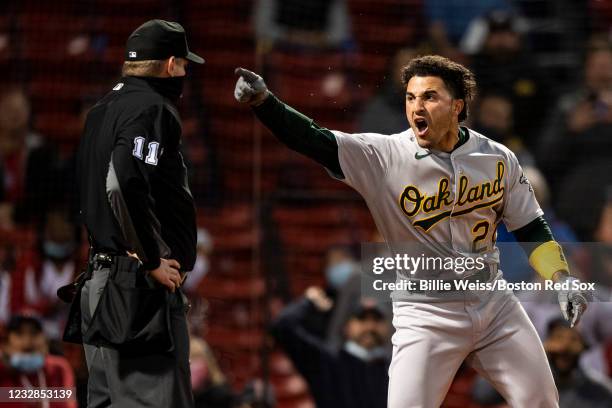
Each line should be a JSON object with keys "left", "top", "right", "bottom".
{"left": 125, "top": 20, "right": 204, "bottom": 64}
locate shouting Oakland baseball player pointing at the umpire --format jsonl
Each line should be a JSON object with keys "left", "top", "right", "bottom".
{"left": 234, "top": 56, "right": 587, "bottom": 408}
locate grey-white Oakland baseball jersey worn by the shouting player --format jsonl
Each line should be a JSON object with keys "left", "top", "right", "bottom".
{"left": 333, "top": 128, "right": 543, "bottom": 270}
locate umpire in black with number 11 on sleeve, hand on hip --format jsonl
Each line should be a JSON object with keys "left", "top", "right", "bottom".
{"left": 70, "top": 20, "right": 204, "bottom": 408}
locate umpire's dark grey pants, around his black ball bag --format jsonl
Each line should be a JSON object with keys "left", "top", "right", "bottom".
{"left": 81, "top": 268, "right": 193, "bottom": 408}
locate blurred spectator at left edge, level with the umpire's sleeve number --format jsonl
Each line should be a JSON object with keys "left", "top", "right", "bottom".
{"left": 0, "top": 88, "right": 58, "bottom": 226}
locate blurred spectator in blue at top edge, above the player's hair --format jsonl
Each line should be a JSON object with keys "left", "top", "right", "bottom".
{"left": 424, "top": 0, "right": 512, "bottom": 59}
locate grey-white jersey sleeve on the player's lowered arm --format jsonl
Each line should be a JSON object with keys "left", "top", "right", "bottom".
{"left": 502, "top": 151, "right": 544, "bottom": 231}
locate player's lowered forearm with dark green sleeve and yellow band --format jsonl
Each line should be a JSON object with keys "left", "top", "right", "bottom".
{"left": 514, "top": 216, "right": 569, "bottom": 281}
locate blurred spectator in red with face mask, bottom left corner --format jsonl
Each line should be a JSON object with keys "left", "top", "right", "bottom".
{"left": 0, "top": 316, "right": 77, "bottom": 408}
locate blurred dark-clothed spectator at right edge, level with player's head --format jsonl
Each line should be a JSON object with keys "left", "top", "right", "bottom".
{"left": 538, "top": 44, "right": 612, "bottom": 192}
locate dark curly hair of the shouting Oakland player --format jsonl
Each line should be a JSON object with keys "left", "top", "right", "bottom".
{"left": 402, "top": 55, "right": 476, "bottom": 122}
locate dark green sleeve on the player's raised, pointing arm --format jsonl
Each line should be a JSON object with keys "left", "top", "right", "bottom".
{"left": 253, "top": 94, "right": 343, "bottom": 177}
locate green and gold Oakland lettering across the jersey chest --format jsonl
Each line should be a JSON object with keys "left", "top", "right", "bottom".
{"left": 399, "top": 161, "right": 505, "bottom": 231}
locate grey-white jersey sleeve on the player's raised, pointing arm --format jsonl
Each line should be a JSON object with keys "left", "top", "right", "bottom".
{"left": 332, "top": 130, "right": 391, "bottom": 194}
